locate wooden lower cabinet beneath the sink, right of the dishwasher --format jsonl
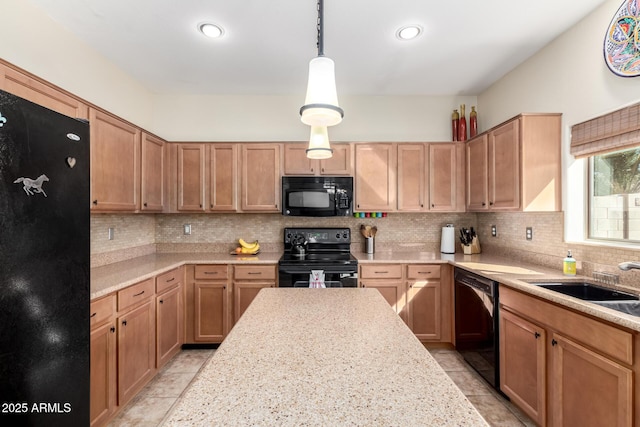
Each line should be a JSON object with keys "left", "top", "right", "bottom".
{"left": 500, "top": 286, "right": 637, "bottom": 426}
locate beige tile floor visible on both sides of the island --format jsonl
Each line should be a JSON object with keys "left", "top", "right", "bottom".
{"left": 108, "top": 349, "right": 535, "bottom": 427}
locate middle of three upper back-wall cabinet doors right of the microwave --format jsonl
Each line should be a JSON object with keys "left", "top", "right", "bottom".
{"left": 398, "top": 144, "right": 427, "bottom": 212}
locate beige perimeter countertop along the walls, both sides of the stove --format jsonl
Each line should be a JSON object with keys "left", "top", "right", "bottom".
{"left": 91, "top": 251, "right": 640, "bottom": 332}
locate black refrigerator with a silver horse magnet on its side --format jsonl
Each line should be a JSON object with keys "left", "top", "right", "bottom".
{"left": 0, "top": 91, "right": 90, "bottom": 426}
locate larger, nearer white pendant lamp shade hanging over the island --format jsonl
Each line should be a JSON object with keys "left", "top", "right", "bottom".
{"left": 300, "top": 56, "right": 344, "bottom": 126}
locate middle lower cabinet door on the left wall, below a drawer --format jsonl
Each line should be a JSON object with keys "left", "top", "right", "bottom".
{"left": 118, "top": 300, "right": 156, "bottom": 406}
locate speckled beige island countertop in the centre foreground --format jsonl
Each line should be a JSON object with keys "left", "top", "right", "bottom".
{"left": 163, "top": 288, "right": 487, "bottom": 426}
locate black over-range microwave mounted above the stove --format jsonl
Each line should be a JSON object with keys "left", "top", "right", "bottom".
{"left": 282, "top": 176, "right": 353, "bottom": 216}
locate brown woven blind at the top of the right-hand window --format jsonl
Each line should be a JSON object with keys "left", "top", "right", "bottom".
{"left": 570, "top": 103, "right": 640, "bottom": 158}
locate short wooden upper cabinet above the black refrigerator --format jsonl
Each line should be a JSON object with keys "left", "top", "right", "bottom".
{"left": 0, "top": 62, "right": 89, "bottom": 119}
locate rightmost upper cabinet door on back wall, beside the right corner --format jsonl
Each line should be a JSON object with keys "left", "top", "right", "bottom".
{"left": 428, "top": 143, "right": 464, "bottom": 212}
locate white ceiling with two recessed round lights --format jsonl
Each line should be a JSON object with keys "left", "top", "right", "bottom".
{"left": 29, "top": 0, "right": 615, "bottom": 96}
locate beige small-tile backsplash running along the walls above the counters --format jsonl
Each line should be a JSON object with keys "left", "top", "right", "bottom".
{"left": 91, "top": 212, "right": 640, "bottom": 288}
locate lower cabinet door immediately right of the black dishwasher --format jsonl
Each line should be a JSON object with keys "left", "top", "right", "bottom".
{"left": 500, "top": 310, "right": 547, "bottom": 425}
